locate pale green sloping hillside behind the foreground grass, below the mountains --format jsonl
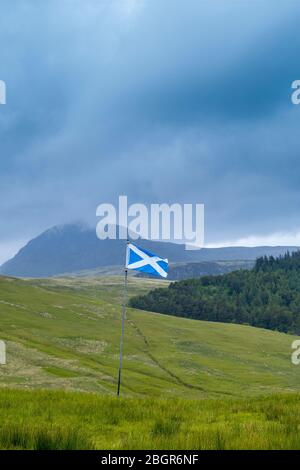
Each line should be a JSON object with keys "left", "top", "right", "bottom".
{"left": 0, "top": 277, "right": 300, "bottom": 398}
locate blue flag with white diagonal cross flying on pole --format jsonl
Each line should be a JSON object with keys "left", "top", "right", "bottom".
{"left": 126, "top": 243, "right": 169, "bottom": 277}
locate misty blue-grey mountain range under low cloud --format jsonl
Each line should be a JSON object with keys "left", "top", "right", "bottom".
{"left": 0, "top": 224, "right": 298, "bottom": 277}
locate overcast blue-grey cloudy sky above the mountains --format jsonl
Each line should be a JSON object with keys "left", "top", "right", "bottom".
{"left": 0, "top": 0, "right": 300, "bottom": 262}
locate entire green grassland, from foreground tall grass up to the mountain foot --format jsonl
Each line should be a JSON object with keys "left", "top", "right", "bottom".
{"left": 0, "top": 277, "right": 300, "bottom": 449}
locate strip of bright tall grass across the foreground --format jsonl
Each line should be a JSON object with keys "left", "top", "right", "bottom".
{"left": 0, "top": 389, "right": 300, "bottom": 450}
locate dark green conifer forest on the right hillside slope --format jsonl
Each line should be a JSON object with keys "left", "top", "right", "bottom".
{"left": 130, "top": 252, "right": 300, "bottom": 334}
